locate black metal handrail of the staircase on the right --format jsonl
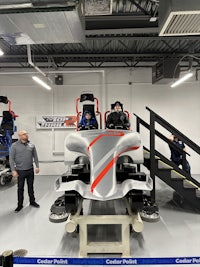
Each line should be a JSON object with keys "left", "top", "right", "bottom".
{"left": 134, "top": 107, "right": 200, "bottom": 202}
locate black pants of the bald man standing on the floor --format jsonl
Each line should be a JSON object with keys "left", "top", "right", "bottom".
{"left": 17, "top": 169, "right": 35, "bottom": 206}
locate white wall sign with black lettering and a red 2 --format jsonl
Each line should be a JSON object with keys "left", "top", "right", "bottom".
{"left": 36, "top": 115, "right": 77, "bottom": 129}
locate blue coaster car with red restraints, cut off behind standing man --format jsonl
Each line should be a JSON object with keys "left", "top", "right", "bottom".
{"left": 0, "top": 96, "right": 17, "bottom": 185}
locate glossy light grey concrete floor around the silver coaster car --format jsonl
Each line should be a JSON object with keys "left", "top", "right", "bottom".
{"left": 0, "top": 175, "right": 200, "bottom": 258}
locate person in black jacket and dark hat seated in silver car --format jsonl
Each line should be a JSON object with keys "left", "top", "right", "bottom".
{"left": 106, "top": 101, "right": 130, "bottom": 130}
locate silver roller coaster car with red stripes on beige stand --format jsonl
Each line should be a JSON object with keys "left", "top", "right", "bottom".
{"left": 49, "top": 94, "right": 153, "bottom": 222}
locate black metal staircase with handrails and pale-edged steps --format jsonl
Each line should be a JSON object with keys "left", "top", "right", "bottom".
{"left": 134, "top": 107, "right": 200, "bottom": 211}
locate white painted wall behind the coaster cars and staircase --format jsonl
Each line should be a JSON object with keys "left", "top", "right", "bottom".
{"left": 0, "top": 68, "right": 200, "bottom": 175}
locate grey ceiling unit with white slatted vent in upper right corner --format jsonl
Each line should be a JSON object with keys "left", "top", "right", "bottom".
{"left": 159, "top": 0, "right": 200, "bottom": 36}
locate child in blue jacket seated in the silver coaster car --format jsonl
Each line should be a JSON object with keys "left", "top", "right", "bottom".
{"left": 78, "top": 111, "right": 98, "bottom": 130}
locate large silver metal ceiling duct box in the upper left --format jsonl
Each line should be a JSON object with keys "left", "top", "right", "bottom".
{"left": 0, "top": 1, "right": 85, "bottom": 45}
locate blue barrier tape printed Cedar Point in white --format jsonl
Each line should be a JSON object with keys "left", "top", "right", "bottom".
{"left": 13, "top": 257, "right": 200, "bottom": 267}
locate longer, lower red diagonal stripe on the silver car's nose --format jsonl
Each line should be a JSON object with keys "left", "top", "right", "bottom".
{"left": 91, "top": 146, "right": 139, "bottom": 193}
